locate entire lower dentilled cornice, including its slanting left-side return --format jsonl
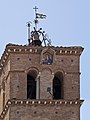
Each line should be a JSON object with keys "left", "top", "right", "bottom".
{"left": 0, "top": 99, "right": 84, "bottom": 120}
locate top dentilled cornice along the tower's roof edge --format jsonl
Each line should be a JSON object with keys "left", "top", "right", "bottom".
{"left": 0, "top": 44, "right": 84, "bottom": 73}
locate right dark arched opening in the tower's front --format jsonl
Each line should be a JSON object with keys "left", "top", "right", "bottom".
{"left": 53, "top": 72, "right": 63, "bottom": 99}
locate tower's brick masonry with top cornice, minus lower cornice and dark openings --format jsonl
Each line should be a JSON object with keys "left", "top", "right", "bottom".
{"left": 0, "top": 44, "right": 83, "bottom": 120}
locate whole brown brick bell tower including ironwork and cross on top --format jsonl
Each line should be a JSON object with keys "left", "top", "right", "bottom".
{"left": 0, "top": 7, "right": 83, "bottom": 120}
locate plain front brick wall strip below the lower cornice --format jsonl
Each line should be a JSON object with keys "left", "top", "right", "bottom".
{"left": 10, "top": 105, "right": 79, "bottom": 120}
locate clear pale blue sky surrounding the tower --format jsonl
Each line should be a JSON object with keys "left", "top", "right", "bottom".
{"left": 0, "top": 0, "right": 90, "bottom": 120}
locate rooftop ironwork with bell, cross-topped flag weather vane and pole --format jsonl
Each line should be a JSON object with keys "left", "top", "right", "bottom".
{"left": 27, "top": 6, "right": 51, "bottom": 46}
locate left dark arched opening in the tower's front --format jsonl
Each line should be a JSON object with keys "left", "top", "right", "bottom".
{"left": 27, "top": 71, "right": 37, "bottom": 99}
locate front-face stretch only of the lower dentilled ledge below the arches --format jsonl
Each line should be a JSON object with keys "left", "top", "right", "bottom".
{"left": 8, "top": 99, "right": 82, "bottom": 105}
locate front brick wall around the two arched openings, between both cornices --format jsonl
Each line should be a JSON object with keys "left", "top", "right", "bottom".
{"left": 10, "top": 50, "right": 80, "bottom": 99}
